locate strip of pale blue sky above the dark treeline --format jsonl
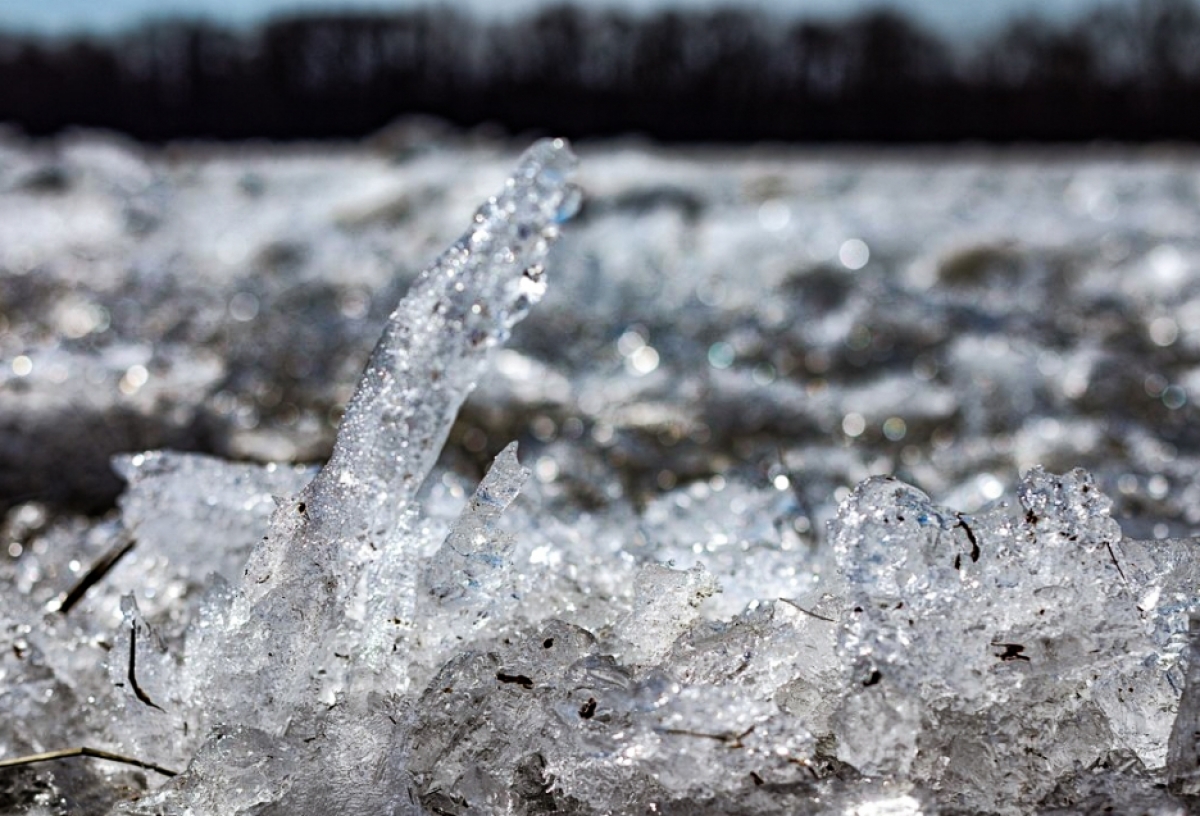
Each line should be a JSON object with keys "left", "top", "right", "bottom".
{"left": 0, "top": 0, "right": 1135, "bottom": 37}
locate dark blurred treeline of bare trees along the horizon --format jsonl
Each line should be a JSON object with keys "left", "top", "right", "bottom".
{"left": 0, "top": 0, "right": 1200, "bottom": 142}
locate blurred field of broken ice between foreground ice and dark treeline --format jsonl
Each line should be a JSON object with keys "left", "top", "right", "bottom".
{"left": 0, "top": 129, "right": 1200, "bottom": 547}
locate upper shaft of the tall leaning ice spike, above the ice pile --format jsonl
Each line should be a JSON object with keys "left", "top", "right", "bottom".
{"left": 308, "top": 139, "right": 578, "bottom": 542}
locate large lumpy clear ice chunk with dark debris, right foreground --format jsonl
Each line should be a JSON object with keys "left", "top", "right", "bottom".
{"left": 833, "top": 468, "right": 1195, "bottom": 811}
